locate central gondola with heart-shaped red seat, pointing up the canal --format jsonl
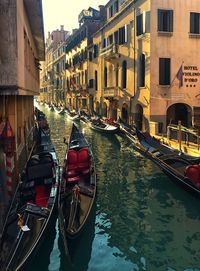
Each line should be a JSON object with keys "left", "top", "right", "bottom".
{"left": 58, "top": 124, "right": 96, "bottom": 242}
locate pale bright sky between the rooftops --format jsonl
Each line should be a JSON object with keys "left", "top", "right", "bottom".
{"left": 42, "top": 0, "right": 108, "bottom": 38}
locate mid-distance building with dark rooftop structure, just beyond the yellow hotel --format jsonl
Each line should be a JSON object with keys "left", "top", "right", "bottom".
{"left": 66, "top": 6, "right": 105, "bottom": 110}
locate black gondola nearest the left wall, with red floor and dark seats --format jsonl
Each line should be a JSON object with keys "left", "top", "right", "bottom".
{"left": 0, "top": 148, "right": 59, "bottom": 271}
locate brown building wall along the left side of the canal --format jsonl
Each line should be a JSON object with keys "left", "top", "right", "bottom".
{"left": 0, "top": 0, "right": 45, "bottom": 198}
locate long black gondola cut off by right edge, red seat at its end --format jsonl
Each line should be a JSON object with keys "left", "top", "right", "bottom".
{"left": 134, "top": 128, "right": 200, "bottom": 196}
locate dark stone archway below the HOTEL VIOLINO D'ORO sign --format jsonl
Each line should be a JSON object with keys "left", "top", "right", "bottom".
{"left": 166, "top": 103, "right": 192, "bottom": 127}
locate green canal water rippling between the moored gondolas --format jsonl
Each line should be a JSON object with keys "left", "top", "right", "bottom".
{"left": 27, "top": 106, "right": 200, "bottom": 271}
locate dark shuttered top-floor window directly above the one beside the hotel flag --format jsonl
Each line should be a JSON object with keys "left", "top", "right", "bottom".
{"left": 158, "top": 9, "right": 173, "bottom": 32}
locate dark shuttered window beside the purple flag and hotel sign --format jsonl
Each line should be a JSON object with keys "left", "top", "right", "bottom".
{"left": 159, "top": 58, "right": 171, "bottom": 85}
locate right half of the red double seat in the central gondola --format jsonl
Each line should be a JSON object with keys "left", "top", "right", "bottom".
{"left": 78, "top": 148, "right": 91, "bottom": 175}
